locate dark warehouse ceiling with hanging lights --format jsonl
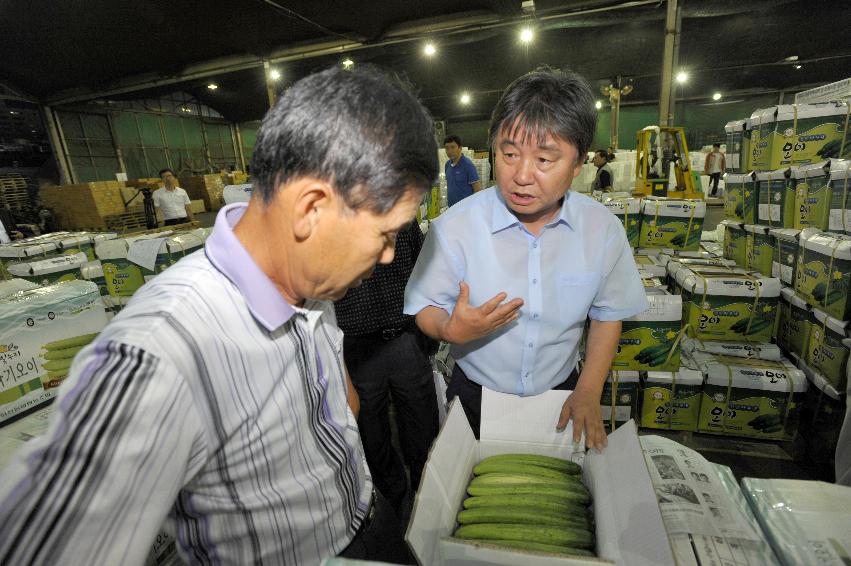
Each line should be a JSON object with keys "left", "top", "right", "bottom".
{"left": 0, "top": 0, "right": 851, "bottom": 121}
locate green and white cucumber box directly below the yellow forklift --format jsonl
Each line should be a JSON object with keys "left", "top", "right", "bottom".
{"left": 638, "top": 198, "right": 706, "bottom": 251}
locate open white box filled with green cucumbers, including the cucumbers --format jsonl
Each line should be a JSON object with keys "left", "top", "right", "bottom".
{"left": 405, "top": 389, "right": 675, "bottom": 566}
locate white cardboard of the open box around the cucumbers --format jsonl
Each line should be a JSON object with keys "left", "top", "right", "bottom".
{"left": 405, "top": 388, "right": 675, "bottom": 566}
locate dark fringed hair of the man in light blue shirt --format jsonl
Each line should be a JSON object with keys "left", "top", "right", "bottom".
{"left": 490, "top": 67, "right": 597, "bottom": 164}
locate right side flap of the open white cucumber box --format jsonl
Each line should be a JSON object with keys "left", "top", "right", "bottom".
{"left": 584, "top": 420, "right": 675, "bottom": 566}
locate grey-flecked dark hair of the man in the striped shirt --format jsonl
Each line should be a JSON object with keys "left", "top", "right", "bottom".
{"left": 251, "top": 66, "right": 438, "bottom": 214}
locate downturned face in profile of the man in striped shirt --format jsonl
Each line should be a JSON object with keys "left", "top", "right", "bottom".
{"left": 310, "top": 190, "right": 421, "bottom": 300}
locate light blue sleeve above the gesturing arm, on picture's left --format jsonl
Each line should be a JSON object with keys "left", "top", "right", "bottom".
{"left": 404, "top": 225, "right": 464, "bottom": 316}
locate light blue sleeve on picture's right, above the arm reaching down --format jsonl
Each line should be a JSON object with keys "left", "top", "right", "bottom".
{"left": 588, "top": 226, "right": 649, "bottom": 321}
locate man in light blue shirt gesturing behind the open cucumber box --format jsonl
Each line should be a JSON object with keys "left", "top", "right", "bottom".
{"left": 405, "top": 69, "right": 647, "bottom": 448}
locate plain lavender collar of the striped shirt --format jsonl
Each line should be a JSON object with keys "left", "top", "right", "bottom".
{"left": 205, "top": 203, "right": 296, "bottom": 332}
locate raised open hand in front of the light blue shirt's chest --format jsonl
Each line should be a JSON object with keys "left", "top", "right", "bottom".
{"left": 443, "top": 281, "right": 523, "bottom": 344}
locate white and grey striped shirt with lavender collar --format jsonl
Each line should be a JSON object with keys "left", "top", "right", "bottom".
{"left": 0, "top": 204, "right": 372, "bottom": 565}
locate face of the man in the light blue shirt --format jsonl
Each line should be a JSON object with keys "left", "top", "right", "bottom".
{"left": 494, "top": 129, "right": 582, "bottom": 222}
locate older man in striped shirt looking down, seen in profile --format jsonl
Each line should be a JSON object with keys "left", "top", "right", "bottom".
{"left": 0, "top": 69, "right": 438, "bottom": 566}
